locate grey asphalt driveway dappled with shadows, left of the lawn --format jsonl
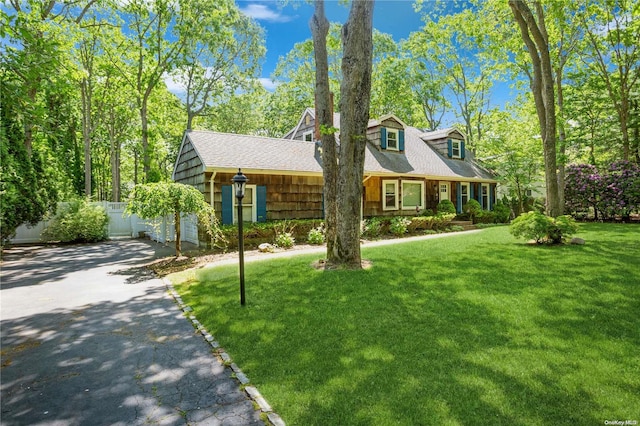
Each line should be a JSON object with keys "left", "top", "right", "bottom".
{"left": 0, "top": 240, "right": 264, "bottom": 426}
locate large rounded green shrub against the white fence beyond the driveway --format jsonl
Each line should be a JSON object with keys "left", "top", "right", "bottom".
{"left": 42, "top": 199, "right": 109, "bottom": 243}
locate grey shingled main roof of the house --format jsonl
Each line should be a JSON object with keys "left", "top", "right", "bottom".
{"left": 178, "top": 120, "right": 495, "bottom": 182}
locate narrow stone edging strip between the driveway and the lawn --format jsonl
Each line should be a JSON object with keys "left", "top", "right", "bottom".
{"left": 162, "top": 278, "right": 285, "bottom": 426}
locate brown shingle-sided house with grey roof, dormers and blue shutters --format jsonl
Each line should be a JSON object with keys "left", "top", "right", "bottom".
{"left": 173, "top": 108, "right": 497, "bottom": 224}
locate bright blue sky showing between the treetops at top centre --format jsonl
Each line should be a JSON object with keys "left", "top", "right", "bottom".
{"left": 236, "top": 0, "right": 422, "bottom": 88}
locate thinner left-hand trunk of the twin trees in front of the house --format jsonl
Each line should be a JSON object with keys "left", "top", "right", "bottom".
{"left": 309, "top": 0, "right": 338, "bottom": 263}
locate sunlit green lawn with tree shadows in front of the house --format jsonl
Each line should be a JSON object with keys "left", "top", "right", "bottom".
{"left": 172, "top": 224, "right": 640, "bottom": 425}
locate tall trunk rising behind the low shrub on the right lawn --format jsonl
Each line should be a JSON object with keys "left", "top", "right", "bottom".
{"left": 509, "top": 0, "right": 563, "bottom": 217}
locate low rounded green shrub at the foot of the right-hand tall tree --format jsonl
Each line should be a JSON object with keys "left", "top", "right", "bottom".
{"left": 509, "top": 211, "right": 578, "bottom": 244}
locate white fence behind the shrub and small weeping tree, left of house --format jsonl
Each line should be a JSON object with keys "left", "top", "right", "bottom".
{"left": 11, "top": 201, "right": 198, "bottom": 245}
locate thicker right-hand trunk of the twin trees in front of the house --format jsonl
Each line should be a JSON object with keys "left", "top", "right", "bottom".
{"left": 336, "top": 0, "right": 374, "bottom": 269}
